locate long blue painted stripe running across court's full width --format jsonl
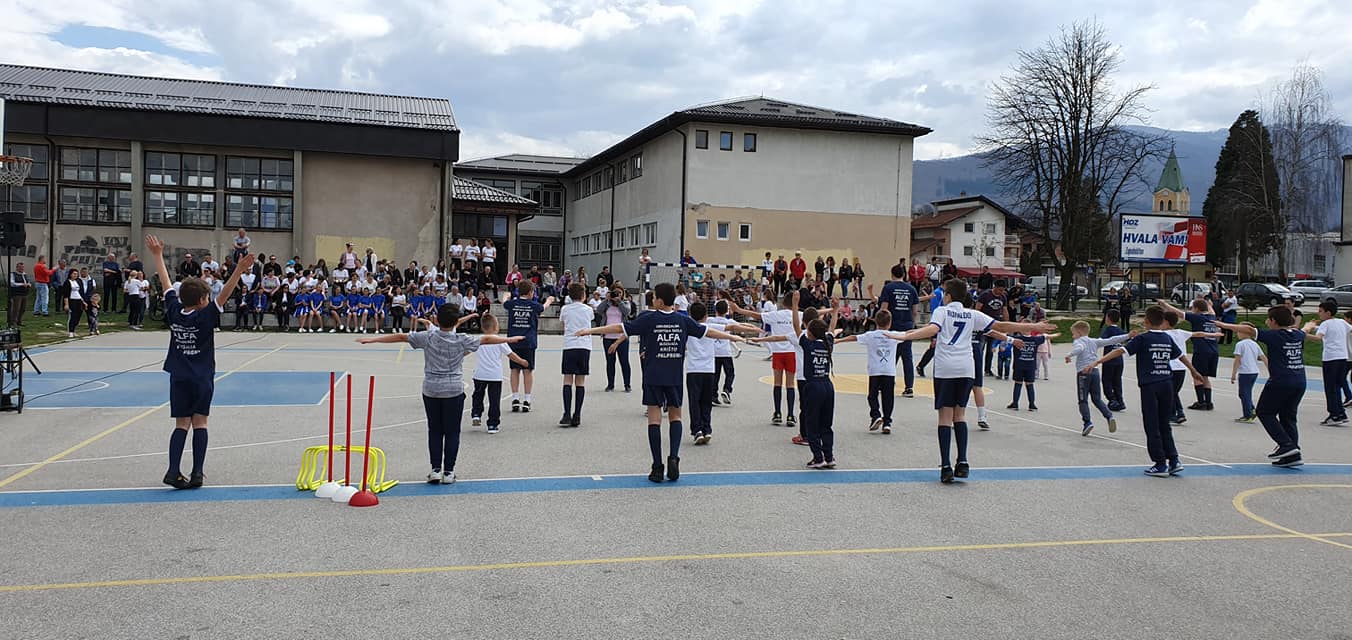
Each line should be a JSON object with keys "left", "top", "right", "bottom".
{"left": 0, "top": 463, "right": 1352, "bottom": 509}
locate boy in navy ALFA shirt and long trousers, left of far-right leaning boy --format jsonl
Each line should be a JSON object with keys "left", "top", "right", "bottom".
{"left": 1080, "top": 306, "right": 1202, "bottom": 478}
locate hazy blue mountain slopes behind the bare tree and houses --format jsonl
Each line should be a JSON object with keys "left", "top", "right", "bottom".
{"left": 911, "top": 127, "right": 1352, "bottom": 229}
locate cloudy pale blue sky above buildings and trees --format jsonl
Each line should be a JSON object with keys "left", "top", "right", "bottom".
{"left": 0, "top": 0, "right": 1352, "bottom": 158}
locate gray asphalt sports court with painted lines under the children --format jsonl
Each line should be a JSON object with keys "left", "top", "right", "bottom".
{"left": 0, "top": 333, "right": 1352, "bottom": 637}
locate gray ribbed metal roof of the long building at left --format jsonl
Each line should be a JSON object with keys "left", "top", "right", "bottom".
{"left": 0, "top": 65, "right": 458, "bottom": 131}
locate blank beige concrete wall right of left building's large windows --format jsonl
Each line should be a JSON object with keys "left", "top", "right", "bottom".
{"left": 299, "top": 153, "right": 438, "bottom": 264}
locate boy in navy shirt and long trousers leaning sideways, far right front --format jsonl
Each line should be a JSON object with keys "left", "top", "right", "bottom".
{"left": 1217, "top": 306, "right": 1305, "bottom": 467}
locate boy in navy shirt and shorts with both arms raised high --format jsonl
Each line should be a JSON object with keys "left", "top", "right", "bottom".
{"left": 146, "top": 235, "right": 254, "bottom": 488}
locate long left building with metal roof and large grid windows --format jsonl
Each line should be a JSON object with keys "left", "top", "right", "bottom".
{"left": 0, "top": 65, "right": 551, "bottom": 269}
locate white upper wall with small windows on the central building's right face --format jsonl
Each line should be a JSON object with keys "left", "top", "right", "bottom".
{"left": 684, "top": 123, "right": 914, "bottom": 215}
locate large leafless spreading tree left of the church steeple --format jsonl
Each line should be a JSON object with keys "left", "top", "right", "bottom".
{"left": 977, "top": 22, "right": 1169, "bottom": 307}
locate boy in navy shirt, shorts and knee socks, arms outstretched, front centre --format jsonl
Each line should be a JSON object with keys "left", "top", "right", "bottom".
{"left": 570, "top": 281, "right": 742, "bottom": 482}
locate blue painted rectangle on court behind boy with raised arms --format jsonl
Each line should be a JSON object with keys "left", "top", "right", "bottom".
{"left": 23, "top": 371, "right": 329, "bottom": 409}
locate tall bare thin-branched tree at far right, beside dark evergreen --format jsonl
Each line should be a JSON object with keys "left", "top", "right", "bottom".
{"left": 1265, "top": 62, "right": 1343, "bottom": 280}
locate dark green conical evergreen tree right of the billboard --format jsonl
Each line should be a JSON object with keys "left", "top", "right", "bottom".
{"left": 1202, "top": 110, "right": 1283, "bottom": 281}
